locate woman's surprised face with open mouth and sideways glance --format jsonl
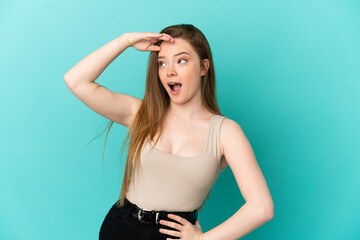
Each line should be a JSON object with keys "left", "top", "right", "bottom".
{"left": 158, "top": 38, "right": 207, "bottom": 102}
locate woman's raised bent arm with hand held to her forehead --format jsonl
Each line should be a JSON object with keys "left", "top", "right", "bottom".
{"left": 64, "top": 32, "right": 169, "bottom": 127}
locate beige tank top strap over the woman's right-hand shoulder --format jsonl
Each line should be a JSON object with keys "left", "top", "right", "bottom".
{"left": 206, "top": 115, "right": 225, "bottom": 159}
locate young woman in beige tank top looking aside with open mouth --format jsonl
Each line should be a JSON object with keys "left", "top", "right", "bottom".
{"left": 64, "top": 24, "right": 274, "bottom": 240}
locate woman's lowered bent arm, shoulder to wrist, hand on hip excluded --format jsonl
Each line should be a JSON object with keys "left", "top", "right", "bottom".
{"left": 203, "top": 118, "right": 274, "bottom": 240}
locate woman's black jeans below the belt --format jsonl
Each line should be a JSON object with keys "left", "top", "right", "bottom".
{"left": 99, "top": 200, "right": 196, "bottom": 240}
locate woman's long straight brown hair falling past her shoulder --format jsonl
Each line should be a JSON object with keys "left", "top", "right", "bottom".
{"left": 91, "top": 24, "right": 222, "bottom": 211}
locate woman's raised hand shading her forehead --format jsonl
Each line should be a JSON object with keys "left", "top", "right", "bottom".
{"left": 123, "top": 32, "right": 175, "bottom": 51}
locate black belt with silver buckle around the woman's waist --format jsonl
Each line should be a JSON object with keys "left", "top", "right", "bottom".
{"left": 125, "top": 198, "right": 198, "bottom": 224}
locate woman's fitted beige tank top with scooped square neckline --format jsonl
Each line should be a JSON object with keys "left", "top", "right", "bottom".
{"left": 126, "top": 115, "right": 227, "bottom": 212}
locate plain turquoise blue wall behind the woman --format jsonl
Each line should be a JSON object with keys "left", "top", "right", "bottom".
{"left": 0, "top": 0, "right": 360, "bottom": 240}
